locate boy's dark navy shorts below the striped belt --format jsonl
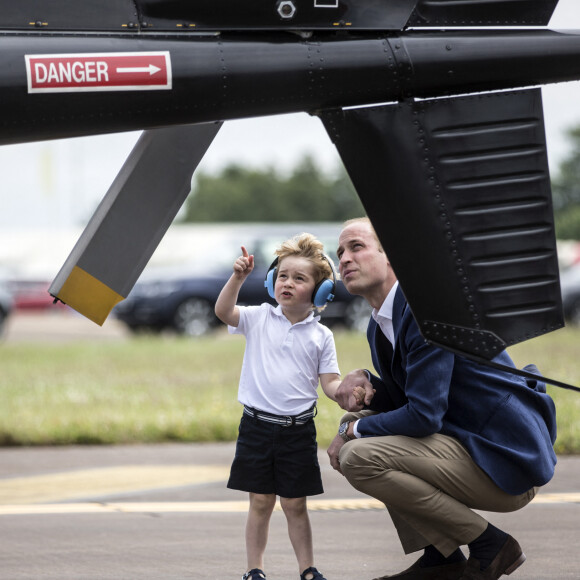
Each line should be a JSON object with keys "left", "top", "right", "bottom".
{"left": 228, "top": 415, "right": 324, "bottom": 498}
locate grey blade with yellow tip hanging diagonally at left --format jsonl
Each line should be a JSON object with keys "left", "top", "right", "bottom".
{"left": 49, "top": 123, "right": 221, "bottom": 324}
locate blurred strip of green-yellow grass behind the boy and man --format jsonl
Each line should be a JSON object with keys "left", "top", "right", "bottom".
{"left": 0, "top": 329, "right": 580, "bottom": 453}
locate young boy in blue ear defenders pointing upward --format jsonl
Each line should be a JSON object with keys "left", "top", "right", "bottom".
{"left": 215, "top": 234, "right": 340, "bottom": 580}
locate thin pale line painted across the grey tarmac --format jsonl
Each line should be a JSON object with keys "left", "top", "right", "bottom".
{"left": 0, "top": 493, "right": 580, "bottom": 516}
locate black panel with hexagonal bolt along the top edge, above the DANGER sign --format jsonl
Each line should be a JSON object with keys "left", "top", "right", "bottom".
{"left": 0, "top": 0, "right": 418, "bottom": 35}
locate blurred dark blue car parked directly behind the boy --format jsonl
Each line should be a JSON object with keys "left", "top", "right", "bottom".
{"left": 114, "top": 224, "right": 370, "bottom": 336}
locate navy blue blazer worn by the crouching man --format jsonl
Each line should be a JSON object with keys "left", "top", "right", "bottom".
{"left": 358, "top": 287, "right": 556, "bottom": 495}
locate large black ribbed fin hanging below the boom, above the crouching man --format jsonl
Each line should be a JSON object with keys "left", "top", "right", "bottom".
{"left": 322, "top": 89, "right": 563, "bottom": 359}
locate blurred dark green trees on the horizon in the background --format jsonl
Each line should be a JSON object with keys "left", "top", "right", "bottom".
{"left": 184, "top": 139, "right": 580, "bottom": 240}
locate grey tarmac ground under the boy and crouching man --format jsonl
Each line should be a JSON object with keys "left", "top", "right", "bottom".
{"left": 0, "top": 443, "right": 580, "bottom": 580}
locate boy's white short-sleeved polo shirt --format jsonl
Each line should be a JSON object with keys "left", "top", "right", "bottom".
{"left": 228, "top": 303, "right": 340, "bottom": 415}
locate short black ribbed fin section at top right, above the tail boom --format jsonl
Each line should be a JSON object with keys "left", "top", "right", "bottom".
{"left": 408, "top": 0, "right": 558, "bottom": 27}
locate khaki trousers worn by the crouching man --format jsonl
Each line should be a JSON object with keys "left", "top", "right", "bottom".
{"left": 339, "top": 411, "right": 537, "bottom": 556}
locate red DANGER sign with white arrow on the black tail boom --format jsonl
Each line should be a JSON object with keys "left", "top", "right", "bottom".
{"left": 24, "top": 52, "right": 172, "bottom": 93}
